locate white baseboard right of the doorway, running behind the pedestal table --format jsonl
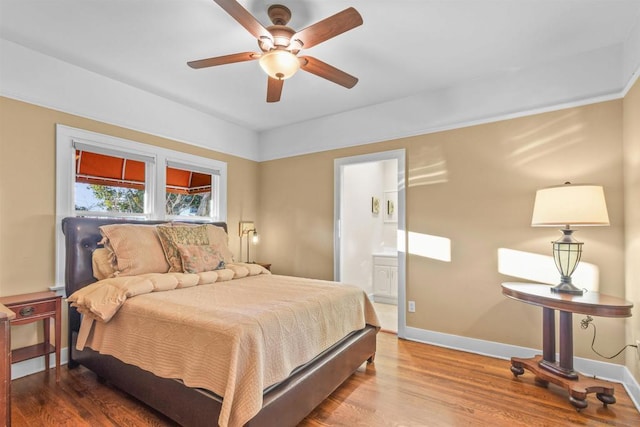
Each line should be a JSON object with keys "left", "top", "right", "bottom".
{"left": 405, "top": 326, "right": 640, "bottom": 411}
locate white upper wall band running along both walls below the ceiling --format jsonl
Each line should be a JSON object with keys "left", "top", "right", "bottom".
{"left": 0, "top": 33, "right": 640, "bottom": 161}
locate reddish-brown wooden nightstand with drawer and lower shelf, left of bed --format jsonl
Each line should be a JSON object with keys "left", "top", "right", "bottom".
{"left": 0, "top": 291, "right": 62, "bottom": 382}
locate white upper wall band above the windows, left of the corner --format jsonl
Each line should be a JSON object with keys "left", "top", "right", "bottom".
{"left": 0, "top": 38, "right": 258, "bottom": 160}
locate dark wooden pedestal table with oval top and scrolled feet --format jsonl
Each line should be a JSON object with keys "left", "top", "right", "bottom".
{"left": 502, "top": 283, "right": 633, "bottom": 410}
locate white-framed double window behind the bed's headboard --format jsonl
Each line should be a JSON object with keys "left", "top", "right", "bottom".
{"left": 52, "top": 125, "right": 227, "bottom": 290}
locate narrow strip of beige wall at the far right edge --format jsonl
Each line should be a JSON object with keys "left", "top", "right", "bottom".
{"left": 623, "top": 80, "right": 640, "bottom": 381}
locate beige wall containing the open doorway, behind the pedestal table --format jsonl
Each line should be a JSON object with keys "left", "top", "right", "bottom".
{"left": 260, "top": 100, "right": 625, "bottom": 363}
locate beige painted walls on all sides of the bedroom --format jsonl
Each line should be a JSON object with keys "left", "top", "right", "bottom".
{"left": 0, "top": 84, "right": 640, "bottom": 378}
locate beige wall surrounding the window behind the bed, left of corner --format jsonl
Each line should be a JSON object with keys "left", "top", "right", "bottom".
{"left": 0, "top": 97, "right": 259, "bottom": 348}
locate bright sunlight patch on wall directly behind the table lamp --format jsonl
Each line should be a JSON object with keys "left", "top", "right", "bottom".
{"left": 498, "top": 248, "right": 600, "bottom": 292}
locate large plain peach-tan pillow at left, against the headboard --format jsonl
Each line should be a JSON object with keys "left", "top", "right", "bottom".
{"left": 100, "top": 224, "right": 169, "bottom": 276}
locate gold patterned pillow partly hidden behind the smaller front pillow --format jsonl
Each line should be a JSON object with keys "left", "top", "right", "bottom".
{"left": 157, "top": 224, "right": 209, "bottom": 273}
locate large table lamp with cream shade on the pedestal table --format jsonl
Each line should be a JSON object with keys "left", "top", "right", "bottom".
{"left": 531, "top": 182, "right": 609, "bottom": 295}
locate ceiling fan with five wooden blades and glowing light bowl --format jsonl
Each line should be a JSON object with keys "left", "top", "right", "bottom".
{"left": 187, "top": 0, "right": 362, "bottom": 102}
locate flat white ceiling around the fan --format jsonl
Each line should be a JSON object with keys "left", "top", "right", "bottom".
{"left": 0, "top": 0, "right": 640, "bottom": 131}
